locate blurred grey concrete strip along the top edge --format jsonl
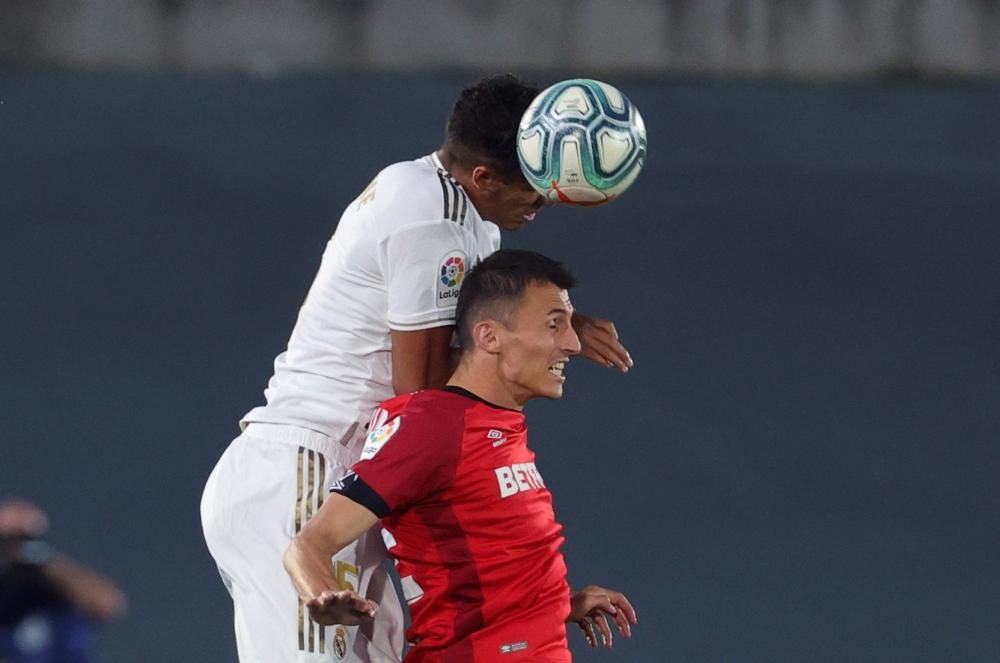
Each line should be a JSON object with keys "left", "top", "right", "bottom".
{"left": 0, "top": 0, "right": 1000, "bottom": 78}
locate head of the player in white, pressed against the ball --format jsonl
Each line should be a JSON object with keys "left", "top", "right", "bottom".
{"left": 438, "top": 74, "right": 544, "bottom": 230}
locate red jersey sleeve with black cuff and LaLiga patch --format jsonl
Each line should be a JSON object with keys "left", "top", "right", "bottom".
{"left": 333, "top": 404, "right": 462, "bottom": 518}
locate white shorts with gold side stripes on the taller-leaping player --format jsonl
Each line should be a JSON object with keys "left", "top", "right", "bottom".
{"left": 201, "top": 423, "right": 404, "bottom": 663}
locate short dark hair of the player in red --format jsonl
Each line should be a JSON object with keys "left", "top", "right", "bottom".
{"left": 455, "top": 249, "right": 576, "bottom": 352}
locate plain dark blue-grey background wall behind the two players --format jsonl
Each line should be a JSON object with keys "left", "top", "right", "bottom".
{"left": 0, "top": 70, "right": 1000, "bottom": 663}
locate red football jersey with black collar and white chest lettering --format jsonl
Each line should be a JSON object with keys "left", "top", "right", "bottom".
{"left": 333, "top": 387, "right": 571, "bottom": 663}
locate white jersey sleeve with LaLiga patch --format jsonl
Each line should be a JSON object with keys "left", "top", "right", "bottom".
{"left": 380, "top": 219, "right": 469, "bottom": 331}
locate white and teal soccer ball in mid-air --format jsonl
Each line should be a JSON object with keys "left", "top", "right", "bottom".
{"left": 517, "top": 78, "right": 646, "bottom": 206}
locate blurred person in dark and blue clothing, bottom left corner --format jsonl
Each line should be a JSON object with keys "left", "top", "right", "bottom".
{"left": 0, "top": 499, "right": 125, "bottom": 663}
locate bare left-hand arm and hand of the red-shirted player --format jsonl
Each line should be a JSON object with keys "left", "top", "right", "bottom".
{"left": 284, "top": 493, "right": 378, "bottom": 625}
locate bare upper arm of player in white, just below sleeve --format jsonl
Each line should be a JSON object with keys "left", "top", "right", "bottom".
{"left": 390, "top": 325, "right": 454, "bottom": 396}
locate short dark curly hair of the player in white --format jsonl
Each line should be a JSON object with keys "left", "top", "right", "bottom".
{"left": 444, "top": 74, "right": 540, "bottom": 183}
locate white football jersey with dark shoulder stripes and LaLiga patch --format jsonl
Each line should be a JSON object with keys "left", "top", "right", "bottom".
{"left": 240, "top": 154, "right": 500, "bottom": 441}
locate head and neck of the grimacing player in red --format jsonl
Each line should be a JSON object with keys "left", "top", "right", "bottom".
{"left": 452, "top": 250, "right": 580, "bottom": 409}
